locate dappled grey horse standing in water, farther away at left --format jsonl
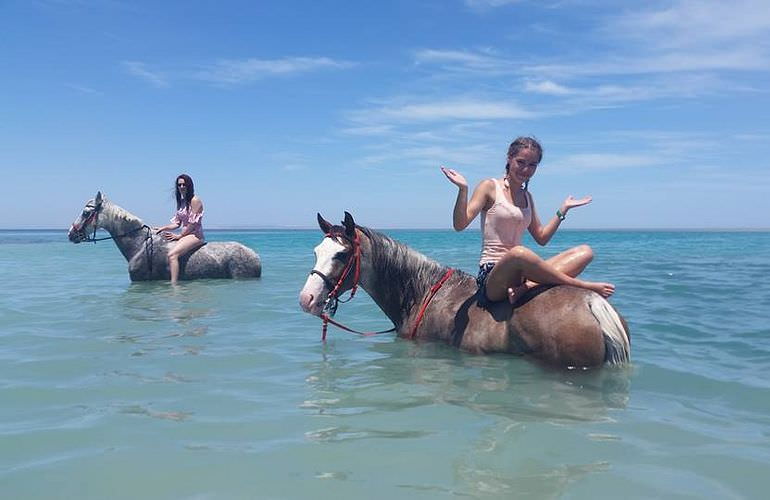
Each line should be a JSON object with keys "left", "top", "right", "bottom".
{"left": 67, "top": 192, "right": 262, "bottom": 281}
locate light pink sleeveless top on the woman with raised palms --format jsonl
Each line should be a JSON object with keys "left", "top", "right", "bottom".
{"left": 479, "top": 179, "right": 532, "bottom": 265}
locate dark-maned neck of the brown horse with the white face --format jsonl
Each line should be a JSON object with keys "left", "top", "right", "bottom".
{"left": 361, "top": 229, "right": 442, "bottom": 328}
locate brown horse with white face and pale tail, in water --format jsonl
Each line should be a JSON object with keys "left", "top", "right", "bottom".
{"left": 299, "top": 212, "right": 630, "bottom": 368}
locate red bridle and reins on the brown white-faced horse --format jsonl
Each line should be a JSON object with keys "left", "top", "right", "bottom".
{"left": 310, "top": 232, "right": 455, "bottom": 341}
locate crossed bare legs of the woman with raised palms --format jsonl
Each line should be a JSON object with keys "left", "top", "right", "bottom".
{"left": 486, "top": 246, "right": 615, "bottom": 302}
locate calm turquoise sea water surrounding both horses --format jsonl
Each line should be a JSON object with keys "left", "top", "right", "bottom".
{"left": 0, "top": 231, "right": 770, "bottom": 499}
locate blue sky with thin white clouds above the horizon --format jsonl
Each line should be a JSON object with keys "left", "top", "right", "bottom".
{"left": 0, "top": 0, "right": 770, "bottom": 229}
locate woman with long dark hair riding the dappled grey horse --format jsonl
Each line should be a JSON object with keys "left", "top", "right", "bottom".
{"left": 155, "top": 174, "right": 205, "bottom": 284}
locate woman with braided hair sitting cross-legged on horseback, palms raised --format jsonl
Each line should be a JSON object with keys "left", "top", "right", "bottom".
{"left": 441, "top": 137, "right": 615, "bottom": 304}
